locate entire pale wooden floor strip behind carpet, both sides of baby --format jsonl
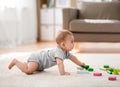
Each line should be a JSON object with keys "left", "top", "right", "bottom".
{"left": 0, "top": 42, "right": 120, "bottom": 54}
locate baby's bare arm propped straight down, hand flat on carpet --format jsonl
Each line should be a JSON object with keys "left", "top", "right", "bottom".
{"left": 56, "top": 58, "right": 70, "bottom": 75}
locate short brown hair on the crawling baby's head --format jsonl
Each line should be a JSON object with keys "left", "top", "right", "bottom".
{"left": 56, "top": 30, "right": 73, "bottom": 44}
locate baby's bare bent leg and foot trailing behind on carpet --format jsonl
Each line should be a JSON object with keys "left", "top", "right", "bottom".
{"left": 8, "top": 59, "right": 39, "bottom": 74}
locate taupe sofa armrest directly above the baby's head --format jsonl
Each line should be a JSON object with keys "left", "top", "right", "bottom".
{"left": 63, "top": 8, "right": 79, "bottom": 29}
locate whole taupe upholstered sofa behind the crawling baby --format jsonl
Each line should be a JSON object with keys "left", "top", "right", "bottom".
{"left": 63, "top": 1, "right": 120, "bottom": 42}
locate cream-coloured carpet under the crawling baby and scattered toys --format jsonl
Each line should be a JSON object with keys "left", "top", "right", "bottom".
{"left": 0, "top": 53, "right": 120, "bottom": 87}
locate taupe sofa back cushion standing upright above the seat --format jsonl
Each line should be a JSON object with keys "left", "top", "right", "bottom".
{"left": 78, "top": 2, "right": 120, "bottom": 19}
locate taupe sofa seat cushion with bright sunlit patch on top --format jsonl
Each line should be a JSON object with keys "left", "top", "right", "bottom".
{"left": 69, "top": 19, "right": 120, "bottom": 33}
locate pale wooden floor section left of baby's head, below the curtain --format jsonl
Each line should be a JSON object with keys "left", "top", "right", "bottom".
{"left": 0, "top": 42, "right": 56, "bottom": 54}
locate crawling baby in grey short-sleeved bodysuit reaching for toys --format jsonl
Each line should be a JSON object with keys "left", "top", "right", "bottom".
{"left": 8, "top": 30, "right": 85, "bottom": 75}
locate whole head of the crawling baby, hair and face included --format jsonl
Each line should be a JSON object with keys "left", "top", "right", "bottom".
{"left": 56, "top": 30, "right": 74, "bottom": 51}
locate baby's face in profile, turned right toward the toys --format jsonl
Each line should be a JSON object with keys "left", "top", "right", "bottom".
{"left": 65, "top": 35, "right": 74, "bottom": 51}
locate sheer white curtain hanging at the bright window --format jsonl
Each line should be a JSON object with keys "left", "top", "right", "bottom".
{"left": 0, "top": 0, "right": 37, "bottom": 48}
